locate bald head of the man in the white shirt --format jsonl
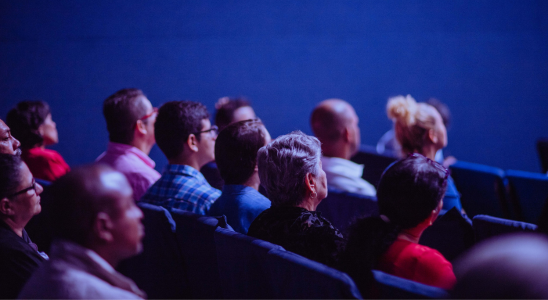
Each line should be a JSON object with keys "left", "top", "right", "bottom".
{"left": 310, "top": 99, "right": 360, "bottom": 159}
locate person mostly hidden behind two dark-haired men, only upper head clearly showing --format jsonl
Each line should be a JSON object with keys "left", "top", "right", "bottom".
{"left": 200, "top": 97, "right": 256, "bottom": 190}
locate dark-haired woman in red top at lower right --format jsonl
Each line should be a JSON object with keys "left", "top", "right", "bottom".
{"left": 341, "top": 154, "right": 455, "bottom": 295}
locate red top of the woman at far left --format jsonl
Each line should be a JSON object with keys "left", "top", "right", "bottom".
{"left": 21, "top": 147, "right": 70, "bottom": 181}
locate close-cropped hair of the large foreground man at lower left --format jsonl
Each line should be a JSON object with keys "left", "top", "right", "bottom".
{"left": 47, "top": 164, "right": 123, "bottom": 245}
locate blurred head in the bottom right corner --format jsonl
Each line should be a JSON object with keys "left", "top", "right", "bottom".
{"left": 453, "top": 233, "right": 548, "bottom": 299}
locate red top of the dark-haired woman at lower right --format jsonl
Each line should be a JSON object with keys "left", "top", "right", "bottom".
{"left": 377, "top": 239, "right": 456, "bottom": 289}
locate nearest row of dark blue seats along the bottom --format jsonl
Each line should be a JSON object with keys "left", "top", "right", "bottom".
{"left": 118, "top": 203, "right": 448, "bottom": 299}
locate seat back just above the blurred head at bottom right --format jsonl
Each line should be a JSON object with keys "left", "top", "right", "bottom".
{"left": 472, "top": 215, "right": 537, "bottom": 242}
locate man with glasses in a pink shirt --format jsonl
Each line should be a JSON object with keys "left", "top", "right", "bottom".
{"left": 96, "top": 89, "right": 160, "bottom": 201}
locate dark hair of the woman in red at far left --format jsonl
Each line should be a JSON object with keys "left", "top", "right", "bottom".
{"left": 6, "top": 100, "right": 51, "bottom": 149}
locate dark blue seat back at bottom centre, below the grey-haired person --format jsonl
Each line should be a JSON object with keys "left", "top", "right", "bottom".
{"left": 267, "top": 249, "right": 362, "bottom": 299}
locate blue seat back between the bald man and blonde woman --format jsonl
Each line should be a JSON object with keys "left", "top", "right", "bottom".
{"left": 350, "top": 145, "right": 397, "bottom": 187}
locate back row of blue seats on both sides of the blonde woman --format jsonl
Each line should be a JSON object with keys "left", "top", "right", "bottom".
{"left": 352, "top": 145, "right": 548, "bottom": 223}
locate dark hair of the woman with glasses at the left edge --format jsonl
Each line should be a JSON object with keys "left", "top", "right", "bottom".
{"left": 0, "top": 153, "right": 23, "bottom": 199}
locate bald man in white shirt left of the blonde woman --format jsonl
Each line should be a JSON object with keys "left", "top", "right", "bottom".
{"left": 310, "top": 99, "right": 376, "bottom": 196}
